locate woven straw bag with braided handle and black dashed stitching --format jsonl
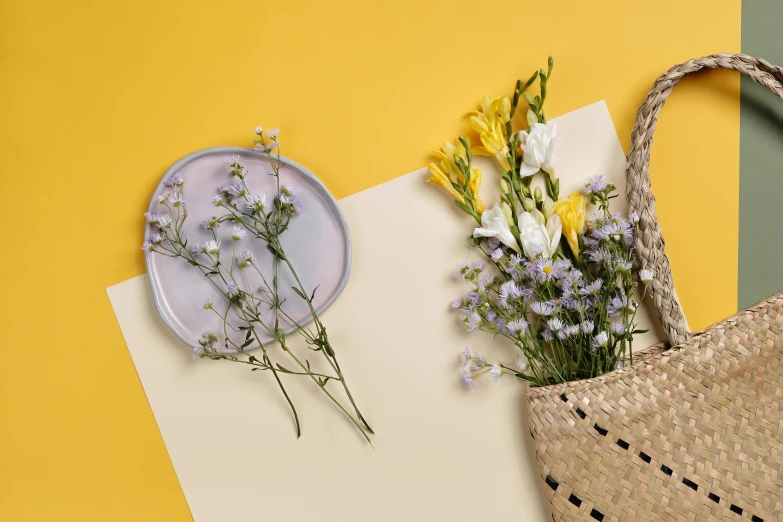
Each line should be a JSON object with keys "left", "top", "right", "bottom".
{"left": 528, "top": 54, "right": 783, "bottom": 522}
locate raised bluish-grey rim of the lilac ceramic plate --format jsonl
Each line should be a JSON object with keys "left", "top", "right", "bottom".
{"left": 144, "top": 147, "right": 352, "bottom": 348}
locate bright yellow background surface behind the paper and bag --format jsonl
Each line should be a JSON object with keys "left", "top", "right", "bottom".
{"left": 0, "top": 0, "right": 740, "bottom": 521}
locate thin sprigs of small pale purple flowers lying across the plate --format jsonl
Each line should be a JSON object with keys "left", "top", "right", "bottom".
{"left": 142, "top": 127, "right": 373, "bottom": 442}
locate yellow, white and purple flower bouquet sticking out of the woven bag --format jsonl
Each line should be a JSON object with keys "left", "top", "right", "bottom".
{"left": 427, "top": 57, "right": 653, "bottom": 388}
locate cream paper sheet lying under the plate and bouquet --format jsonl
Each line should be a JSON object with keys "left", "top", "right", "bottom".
{"left": 108, "top": 102, "right": 658, "bottom": 522}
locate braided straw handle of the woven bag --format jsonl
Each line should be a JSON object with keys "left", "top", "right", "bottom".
{"left": 625, "top": 54, "right": 783, "bottom": 345}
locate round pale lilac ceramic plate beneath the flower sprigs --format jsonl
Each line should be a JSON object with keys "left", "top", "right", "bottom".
{"left": 145, "top": 147, "right": 351, "bottom": 349}
